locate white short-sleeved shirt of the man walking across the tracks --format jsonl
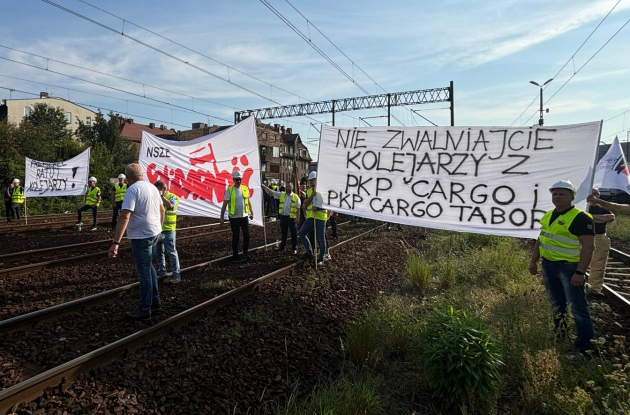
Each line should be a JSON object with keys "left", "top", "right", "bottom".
{"left": 122, "top": 180, "right": 162, "bottom": 239}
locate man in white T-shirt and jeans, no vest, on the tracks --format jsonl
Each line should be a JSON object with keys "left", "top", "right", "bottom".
{"left": 109, "top": 163, "right": 164, "bottom": 320}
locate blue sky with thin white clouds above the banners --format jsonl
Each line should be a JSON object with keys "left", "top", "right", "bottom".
{"left": 0, "top": 0, "right": 630, "bottom": 158}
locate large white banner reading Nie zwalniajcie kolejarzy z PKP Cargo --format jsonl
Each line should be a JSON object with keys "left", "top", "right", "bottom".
{"left": 317, "top": 122, "right": 601, "bottom": 238}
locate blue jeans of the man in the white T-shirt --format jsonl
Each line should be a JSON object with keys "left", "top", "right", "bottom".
{"left": 131, "top": 234, "right": 161, "bottom": 313}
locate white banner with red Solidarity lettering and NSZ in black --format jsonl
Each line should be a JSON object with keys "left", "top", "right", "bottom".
{"left": 139, "top": 117, "right": 263, "bottom": 226}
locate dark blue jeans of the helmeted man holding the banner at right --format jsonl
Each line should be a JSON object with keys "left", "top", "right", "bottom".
{"left": 542, "top": 259, "right": 593, "bottom": 350}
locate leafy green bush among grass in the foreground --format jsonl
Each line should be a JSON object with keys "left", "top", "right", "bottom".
{"left": 418, "top": 307, "right": 503, "bottom": 414}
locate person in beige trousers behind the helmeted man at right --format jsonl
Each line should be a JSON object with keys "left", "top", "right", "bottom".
{"left": 588, "top": 189, "right": 615, "bottom": 297}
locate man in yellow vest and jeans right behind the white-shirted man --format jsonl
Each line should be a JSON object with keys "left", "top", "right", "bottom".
{"left": 154, "top": 180, "right": 182, "bottom": 284}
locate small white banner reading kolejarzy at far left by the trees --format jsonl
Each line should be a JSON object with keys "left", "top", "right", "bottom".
{"left": 24, "top": 148, "right": 90, "bottom": 197}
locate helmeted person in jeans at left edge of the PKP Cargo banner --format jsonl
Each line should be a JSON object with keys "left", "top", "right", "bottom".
{"left": 298, "top": 171, "right": 328, "bottom": 265}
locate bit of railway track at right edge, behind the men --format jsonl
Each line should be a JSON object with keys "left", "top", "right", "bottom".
{"left": 602, "top": 248, "right": 630, "bottom": 314}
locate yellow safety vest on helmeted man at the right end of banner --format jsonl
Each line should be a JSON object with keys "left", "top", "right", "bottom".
{"left": 538, "top": 207, "right": 592, "bottom": 262}
